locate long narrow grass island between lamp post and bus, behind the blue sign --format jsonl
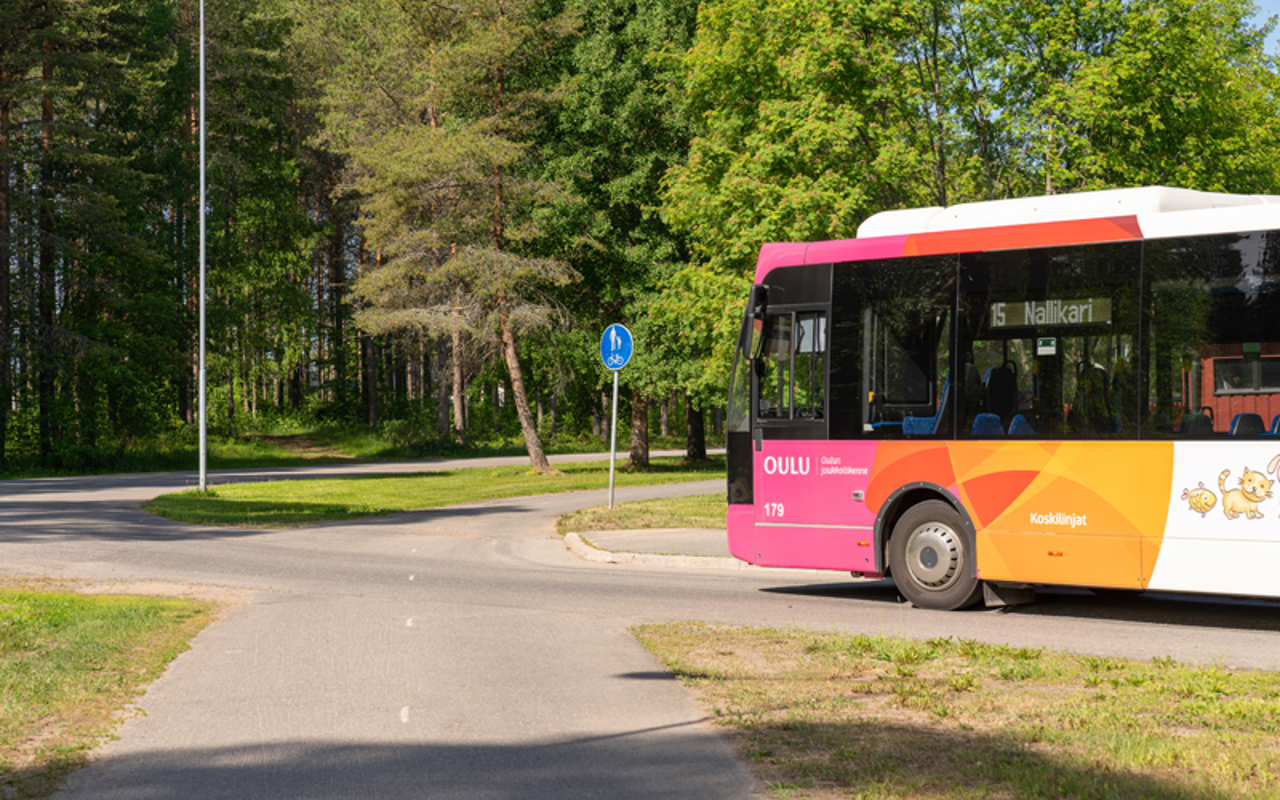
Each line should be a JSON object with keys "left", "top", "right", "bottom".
{"left": 143, "top": 457, "right": 724, "bottom": 527}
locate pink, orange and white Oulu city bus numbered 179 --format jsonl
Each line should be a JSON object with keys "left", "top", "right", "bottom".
{"left": 726, "top": 187, "right": 1280, "bottom": 609}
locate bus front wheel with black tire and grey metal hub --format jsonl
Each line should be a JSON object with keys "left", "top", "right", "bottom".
{"left": 888, "top": 500, "right": 982, "bottom": 611}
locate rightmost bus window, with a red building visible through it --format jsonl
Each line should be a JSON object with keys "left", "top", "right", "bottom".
{"left": 1143, "top": 233, "right": 1280, "bottom": 439}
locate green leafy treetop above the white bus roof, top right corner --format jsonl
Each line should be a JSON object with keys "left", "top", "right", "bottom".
{"left": 970, "top": 0, "right": 1280, "bottom": 193}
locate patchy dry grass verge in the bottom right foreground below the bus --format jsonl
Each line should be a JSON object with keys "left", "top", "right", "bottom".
{"left": 636, "top": 623, "right": 1280, "bottom": 800}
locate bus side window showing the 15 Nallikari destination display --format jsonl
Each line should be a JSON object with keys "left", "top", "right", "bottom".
{"left": 959, "top": 243, "right": 1140, "bottom": 439}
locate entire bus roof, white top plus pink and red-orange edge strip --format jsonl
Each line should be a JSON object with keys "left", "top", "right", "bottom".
{"left": 755, "top": 186, "right": 1280, "bottom": 283}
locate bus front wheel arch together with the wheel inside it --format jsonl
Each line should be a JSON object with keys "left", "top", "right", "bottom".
{"left": 877, "top": 485, "right": 982, "bottom": 611}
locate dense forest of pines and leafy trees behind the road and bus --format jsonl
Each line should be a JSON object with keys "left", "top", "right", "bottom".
{"left": 0, "top": 0, "right": 1280, "bottom": 475}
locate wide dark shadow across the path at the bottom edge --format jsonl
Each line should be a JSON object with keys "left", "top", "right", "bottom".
{"left": 58, "top": 723, "right": 753, "bottom": 800}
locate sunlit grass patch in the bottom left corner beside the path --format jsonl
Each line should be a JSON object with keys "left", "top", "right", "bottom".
{"left": 0, "top": 579, "right": 212, "bottom": 800}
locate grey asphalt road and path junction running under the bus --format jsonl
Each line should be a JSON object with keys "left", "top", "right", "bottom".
{"left": 0, "top": 453, "right": 1280, "bottom": 800}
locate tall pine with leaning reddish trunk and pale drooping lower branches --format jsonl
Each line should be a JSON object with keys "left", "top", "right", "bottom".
{"left": 299, "top": 0, "right": 575, "bottom": 471}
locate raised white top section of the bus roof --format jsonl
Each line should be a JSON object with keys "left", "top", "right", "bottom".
{"left": 858, "top": 186, "right": 1280, "bottom": 239}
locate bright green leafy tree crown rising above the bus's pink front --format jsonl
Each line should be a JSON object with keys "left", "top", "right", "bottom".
{"left": 667, "top": 0, "right": 960, "bottom": 273}
